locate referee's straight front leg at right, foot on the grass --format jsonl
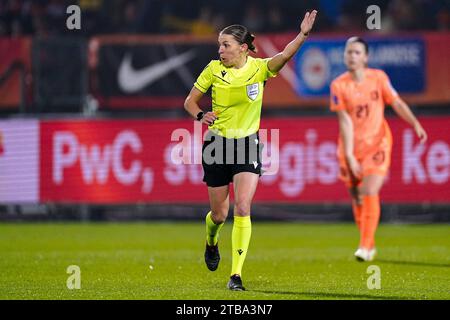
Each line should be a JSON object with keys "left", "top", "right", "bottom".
{"left": 228, "top": 172, "right": 259, "bottom": 290}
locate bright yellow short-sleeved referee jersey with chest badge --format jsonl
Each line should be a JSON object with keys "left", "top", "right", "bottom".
{"left": 194, "top": 56, "right": 276, "bottom": 139}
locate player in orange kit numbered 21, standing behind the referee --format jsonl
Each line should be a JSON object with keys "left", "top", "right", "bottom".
{"left": 330, "top": 37, "right": 427, "bottom": 261}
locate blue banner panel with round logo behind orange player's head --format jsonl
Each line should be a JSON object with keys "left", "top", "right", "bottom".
{"left": 295, "top": 38, "right": 426, "bottom": 97}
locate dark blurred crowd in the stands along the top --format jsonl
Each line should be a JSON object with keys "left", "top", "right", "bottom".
{"left": 0, "top": 0, "right": 450, "bottom": 37}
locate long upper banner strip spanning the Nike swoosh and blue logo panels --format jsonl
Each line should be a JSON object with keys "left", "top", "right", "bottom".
{"left": 89, "top": 32, "right": 450, "bottom": 109}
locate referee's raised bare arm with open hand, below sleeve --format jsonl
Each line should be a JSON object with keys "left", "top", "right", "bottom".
{"left": 267, "top": 10, "right": 317, "bottom": 73}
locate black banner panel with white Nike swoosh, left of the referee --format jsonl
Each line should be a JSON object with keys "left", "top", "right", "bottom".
{"left": 90, "top": 36, "right": 218, "bottom": 108}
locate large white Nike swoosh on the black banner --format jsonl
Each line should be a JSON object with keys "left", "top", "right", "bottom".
{"left": 117, "top": 50, "right": 195, "bottom": 93}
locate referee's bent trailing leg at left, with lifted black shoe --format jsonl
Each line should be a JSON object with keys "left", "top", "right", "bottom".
{"left": 205, "top": 185, "right": 230, "bottom": 271}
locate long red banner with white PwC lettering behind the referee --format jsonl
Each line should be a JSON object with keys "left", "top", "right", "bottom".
{"left": 40, "top": 117, "right": 450, "bottom": 204}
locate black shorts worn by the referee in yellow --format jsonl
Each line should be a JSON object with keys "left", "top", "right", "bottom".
{"left": 202, "top": 131, "right": 262, "bottom": 187}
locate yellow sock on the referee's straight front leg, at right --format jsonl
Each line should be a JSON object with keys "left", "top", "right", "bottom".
{"left": 231, "top": 216, "right": 252, "bottom": 275}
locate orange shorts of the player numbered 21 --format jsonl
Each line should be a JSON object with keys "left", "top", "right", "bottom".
{"left": 338, "top": 134, "right": 392, "bottom": 187}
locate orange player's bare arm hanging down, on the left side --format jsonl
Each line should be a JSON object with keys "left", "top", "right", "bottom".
{"left": 337, "top": 110, "right": 361, "bottom": 177}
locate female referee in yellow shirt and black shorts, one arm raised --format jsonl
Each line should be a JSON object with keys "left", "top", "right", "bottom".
{"left": 184, "top": 10, "right": 317, "bottom": 290}
